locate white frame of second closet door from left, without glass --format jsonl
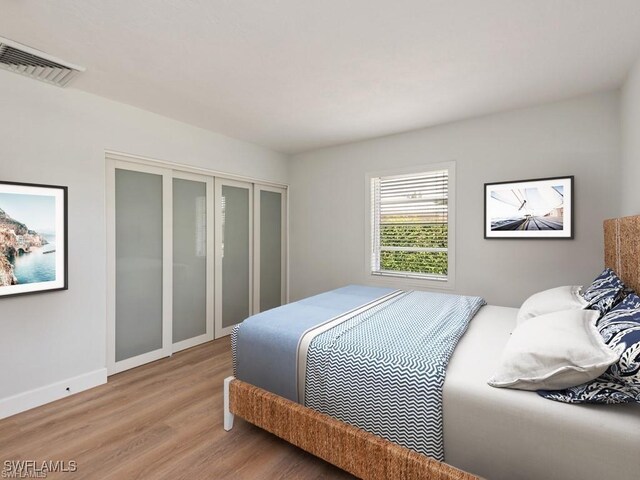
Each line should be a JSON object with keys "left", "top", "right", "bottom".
{"left": 171, "top": 170, "right": 215, "bottom": 353}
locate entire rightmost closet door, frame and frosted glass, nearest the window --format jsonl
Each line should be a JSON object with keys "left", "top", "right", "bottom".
{"left": 253, "top": 185, "right": 287, "bottom": 313}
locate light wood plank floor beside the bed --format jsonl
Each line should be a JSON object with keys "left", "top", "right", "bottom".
{"left": 0, "top": 337, "right": 353, "bottom": 480}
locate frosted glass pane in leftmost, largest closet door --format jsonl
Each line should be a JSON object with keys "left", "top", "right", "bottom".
{"left": 115, "top": 169, "right": 163, "bottom": 361}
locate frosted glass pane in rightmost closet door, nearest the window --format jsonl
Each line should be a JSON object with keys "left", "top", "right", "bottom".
{"left": 260, "top": 190, "right": 282, "bottom": 312}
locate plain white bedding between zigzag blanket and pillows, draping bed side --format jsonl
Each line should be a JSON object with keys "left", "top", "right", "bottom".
{"left": 443, "top": 305, "right": 640, "bottom": 480}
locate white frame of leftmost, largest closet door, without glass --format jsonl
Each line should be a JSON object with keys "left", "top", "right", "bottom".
{"left": 107, "top": 159, "right": 173, "bottom": 375}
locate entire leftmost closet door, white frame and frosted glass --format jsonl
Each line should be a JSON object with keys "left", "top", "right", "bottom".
{"left": 109, "top": 163, "right": 171, "bottom": 373}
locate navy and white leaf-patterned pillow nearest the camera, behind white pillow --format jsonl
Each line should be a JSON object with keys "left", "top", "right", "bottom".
{"left": 538, "top": 293, "right": 640, "bottom": 403}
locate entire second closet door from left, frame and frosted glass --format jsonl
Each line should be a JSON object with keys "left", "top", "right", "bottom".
{"left": 172, "top": 172, "right": 214, "bottom": 352}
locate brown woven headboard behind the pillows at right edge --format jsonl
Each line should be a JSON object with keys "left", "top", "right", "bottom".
{"left": 604, "top": 215, "right": 640, "bottom": 292}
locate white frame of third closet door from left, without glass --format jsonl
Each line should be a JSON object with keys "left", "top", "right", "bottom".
{"left": 213, "top": 177, "right": 255, "bottom": 338}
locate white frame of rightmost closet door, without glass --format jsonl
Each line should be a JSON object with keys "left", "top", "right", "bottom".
{"left": 252, "top": 183, "right": 289, "bottom": 315}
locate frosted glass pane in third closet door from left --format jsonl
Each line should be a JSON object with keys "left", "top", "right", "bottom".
{"left": 217, "top": 184, "right": 252, "bottom": 328}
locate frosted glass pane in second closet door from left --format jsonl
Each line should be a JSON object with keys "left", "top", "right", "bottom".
{"left": 173, "top": 178, "right": 207, "bottom": 343}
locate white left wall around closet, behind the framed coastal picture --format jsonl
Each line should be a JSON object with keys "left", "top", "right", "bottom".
{"left": 0, "top": 71, "right": 287, "bottom": 417}
